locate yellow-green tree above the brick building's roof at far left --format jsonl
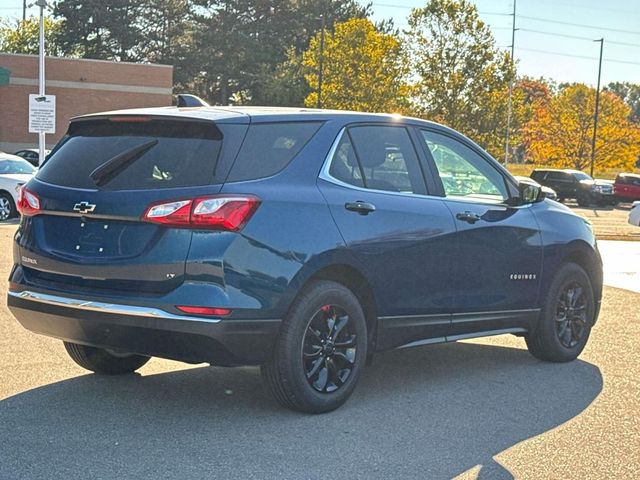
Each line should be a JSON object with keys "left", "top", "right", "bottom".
{"left": 0, "top": 17, "right": 64, "bottom": 56}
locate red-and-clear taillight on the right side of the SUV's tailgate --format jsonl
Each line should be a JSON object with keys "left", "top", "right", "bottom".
{"left": 142, "top": 195, "right": 260, "bottom": 231}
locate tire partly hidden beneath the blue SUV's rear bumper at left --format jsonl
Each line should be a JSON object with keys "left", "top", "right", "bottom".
{"left": 64, "top": 342, "right": 150, "bottom": 375}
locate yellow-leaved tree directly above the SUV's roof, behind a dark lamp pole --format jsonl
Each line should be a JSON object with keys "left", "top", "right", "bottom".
{"left": 303, "top": 19, "right": 408, "bottom": 112}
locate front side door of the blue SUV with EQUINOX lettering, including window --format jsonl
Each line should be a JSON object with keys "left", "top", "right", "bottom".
{"left": 421, "top": 129, "right": 542, "bottom": 339}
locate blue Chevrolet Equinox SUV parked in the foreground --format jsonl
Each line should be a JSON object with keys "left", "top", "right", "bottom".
{"left": 8, "top": 107, "right": 602, "bottom": 413}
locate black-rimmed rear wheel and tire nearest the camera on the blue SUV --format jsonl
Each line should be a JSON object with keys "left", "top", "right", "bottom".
{"left": 261, "top": 281, "right": 368, "bottom": 413}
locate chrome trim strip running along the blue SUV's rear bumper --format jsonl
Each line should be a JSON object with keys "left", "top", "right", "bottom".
{"left": 8, "top": 290, "right": 221, "bottom": 323}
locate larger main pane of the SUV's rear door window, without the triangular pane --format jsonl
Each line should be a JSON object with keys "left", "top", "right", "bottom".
{"left": 347, "top": 126, "right": 425, "bottom": 193}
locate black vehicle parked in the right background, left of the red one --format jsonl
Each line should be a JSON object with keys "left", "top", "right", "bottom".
{"left": 531, "top": 168, "right": 617, "bottom": 207}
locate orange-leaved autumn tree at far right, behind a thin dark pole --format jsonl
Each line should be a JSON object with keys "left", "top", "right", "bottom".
{"left": 523, "top": 84, "right": 640, "bottom": 170}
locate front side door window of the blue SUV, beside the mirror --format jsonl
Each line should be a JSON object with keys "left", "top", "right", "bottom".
{"left": 422, "top": 130, "right": 509, "bottom": 201}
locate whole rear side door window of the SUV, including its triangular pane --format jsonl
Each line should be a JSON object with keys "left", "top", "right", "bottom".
{"left": 329, "top": 126, "right": 426, "bottom": 193}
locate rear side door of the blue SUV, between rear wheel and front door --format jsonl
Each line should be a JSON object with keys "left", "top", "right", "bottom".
{"left": 319, "top": 124, "right": 455, "bottom": 348}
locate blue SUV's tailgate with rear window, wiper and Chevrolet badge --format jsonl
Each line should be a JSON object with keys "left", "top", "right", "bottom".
{"left": 19, "top": 116, "right": 246, "bottom": 294}
